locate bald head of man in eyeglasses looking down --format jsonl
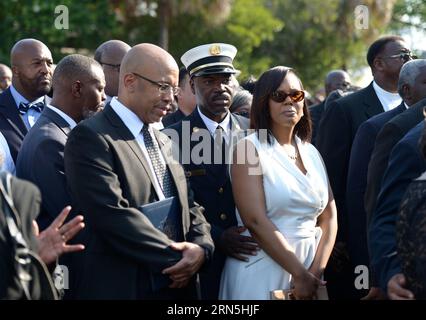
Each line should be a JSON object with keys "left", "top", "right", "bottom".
{"left": 118, "top": 43, "right": 179, "bottom": 123}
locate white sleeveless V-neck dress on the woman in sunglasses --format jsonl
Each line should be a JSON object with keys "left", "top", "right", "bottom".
{"left": 219, "top": 133, "right": 328, "bottom": 300}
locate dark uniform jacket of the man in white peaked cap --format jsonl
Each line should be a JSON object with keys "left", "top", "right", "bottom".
{"left": 164, "top": 109, "right": 249, "bottom": 299}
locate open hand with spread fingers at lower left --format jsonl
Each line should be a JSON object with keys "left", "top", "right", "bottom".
{"left": 33, "top": 206, "right": 84, "bottom": 265}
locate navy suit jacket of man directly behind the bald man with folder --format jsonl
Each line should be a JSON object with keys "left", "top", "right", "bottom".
{"left": 16, "top": 107, "right": 71, "bottom": 230}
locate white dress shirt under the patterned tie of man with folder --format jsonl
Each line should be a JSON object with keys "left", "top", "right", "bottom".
{"left": 110, "top": 97, "right": 166, "bottom": 200}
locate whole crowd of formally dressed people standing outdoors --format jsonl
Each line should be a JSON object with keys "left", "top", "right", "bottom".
{"left": 0, "top": 36, "right": 426, "bottom": 300}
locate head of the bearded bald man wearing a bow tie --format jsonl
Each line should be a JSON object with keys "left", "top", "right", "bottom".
{"left": 10, "top": 39, "right": 53, "bottom": 102}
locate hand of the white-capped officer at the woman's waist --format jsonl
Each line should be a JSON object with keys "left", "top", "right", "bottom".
{"left": 220, "top": 226, "right": 259, "bottom": 261}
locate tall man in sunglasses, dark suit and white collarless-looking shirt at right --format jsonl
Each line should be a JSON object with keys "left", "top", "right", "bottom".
{"left": 317, "top": 36, "right": 411, "bottom": 298}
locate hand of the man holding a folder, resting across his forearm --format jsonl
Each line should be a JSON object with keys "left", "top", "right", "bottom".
{"left": 162, "top": 242, "right": 205, "bottom": 288}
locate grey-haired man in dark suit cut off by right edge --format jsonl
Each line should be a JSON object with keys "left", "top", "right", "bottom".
{"left": 364, "top": 59, "right": 426, "bottom": 222}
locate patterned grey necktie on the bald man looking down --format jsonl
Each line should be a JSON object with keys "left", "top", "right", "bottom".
{"left": 142, "top": 124, "right": 176, "bottom": 198}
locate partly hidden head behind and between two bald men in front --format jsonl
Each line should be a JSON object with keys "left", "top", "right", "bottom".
{"left": 94, "top": 40, "right": 130, "bottom": 103}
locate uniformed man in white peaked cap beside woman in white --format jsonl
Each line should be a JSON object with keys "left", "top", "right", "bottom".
{"left": 165, "top": 44, "right": 257, "bottom": 300}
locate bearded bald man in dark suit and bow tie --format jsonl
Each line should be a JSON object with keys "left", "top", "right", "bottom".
{"left": 0, "top": 39, "right": 53, "bottom": 162}
